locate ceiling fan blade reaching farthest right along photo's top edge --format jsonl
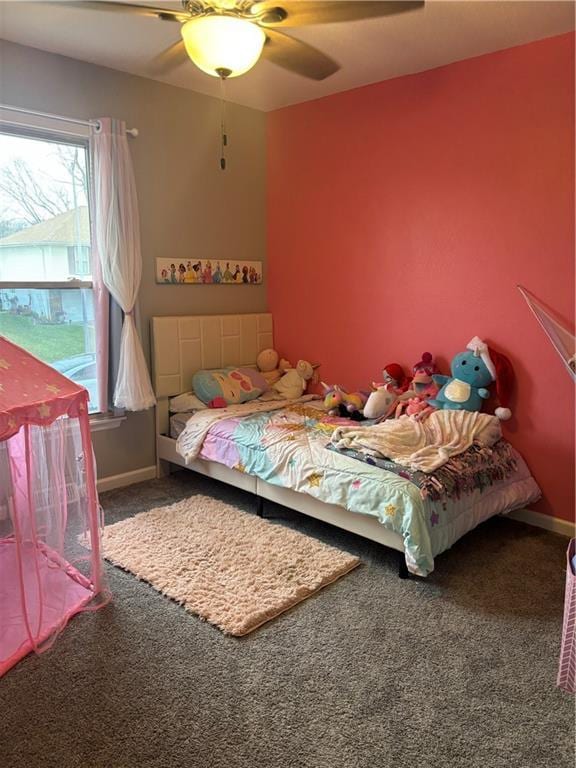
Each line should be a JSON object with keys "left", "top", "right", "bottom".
{"left": 251, "top": 0, "right": 424, "bottom": 29}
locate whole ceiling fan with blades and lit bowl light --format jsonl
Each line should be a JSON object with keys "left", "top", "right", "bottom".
{"left": 55, "top": 0, "right": 424, "bottom": 80}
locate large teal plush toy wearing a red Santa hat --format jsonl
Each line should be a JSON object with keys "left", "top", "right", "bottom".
{"left": 428, "top": 336, "right": 514, "bottom": 420}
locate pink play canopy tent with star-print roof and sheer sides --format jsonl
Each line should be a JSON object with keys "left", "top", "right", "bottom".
{"left": 0, "top": 336, "right": 109, "bottom": 676}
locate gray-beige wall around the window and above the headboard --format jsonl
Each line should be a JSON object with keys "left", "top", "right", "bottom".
{"left": 0, "top": 41, "right": 267, "bottom": 477}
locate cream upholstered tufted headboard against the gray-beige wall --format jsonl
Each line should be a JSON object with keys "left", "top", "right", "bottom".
{"left": 151, "top": 313, "right": 274, "bottom": 400}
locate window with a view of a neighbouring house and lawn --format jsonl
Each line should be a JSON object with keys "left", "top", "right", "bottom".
{"left": 0, "top": 125, "right": 98, "bottom": 413}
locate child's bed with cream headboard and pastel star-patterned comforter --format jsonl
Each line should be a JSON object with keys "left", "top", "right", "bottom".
{"left": 151, "top": 313, "right": 540, "bottom": 577}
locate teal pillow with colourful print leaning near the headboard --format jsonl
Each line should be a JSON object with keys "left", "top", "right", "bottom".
{"left": 192, "top": 368, "right": 269, "bottom": 407}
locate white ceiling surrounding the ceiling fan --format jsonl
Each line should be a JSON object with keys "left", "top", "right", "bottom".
{"left": 0, "top": 0, "right": 575, "bottom": 111}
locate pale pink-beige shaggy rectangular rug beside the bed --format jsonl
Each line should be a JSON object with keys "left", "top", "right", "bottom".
{"left": 104, "top": 496, "right": 360, "bottom": 636}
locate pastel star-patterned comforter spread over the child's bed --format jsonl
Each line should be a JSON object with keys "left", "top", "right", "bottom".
{"left": 177, "top": 402, "right": 540, "bottom": 576}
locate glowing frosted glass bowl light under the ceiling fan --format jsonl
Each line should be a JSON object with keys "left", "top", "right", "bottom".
{"left": 182, "top": 14, "right": 266, "bottom": 77}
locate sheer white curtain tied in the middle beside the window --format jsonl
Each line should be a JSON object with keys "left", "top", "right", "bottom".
{"left": 90, "top": 118, "right": 156, "bottom": 411}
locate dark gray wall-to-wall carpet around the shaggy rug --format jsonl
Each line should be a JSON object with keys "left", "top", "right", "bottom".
{"left": 0, "top": 472, "right": 574, "bottom": 768}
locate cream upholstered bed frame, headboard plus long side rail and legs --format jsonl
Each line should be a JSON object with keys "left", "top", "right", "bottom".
{"left": 151, "top": 313, "right": 408, "bottom": 578}
